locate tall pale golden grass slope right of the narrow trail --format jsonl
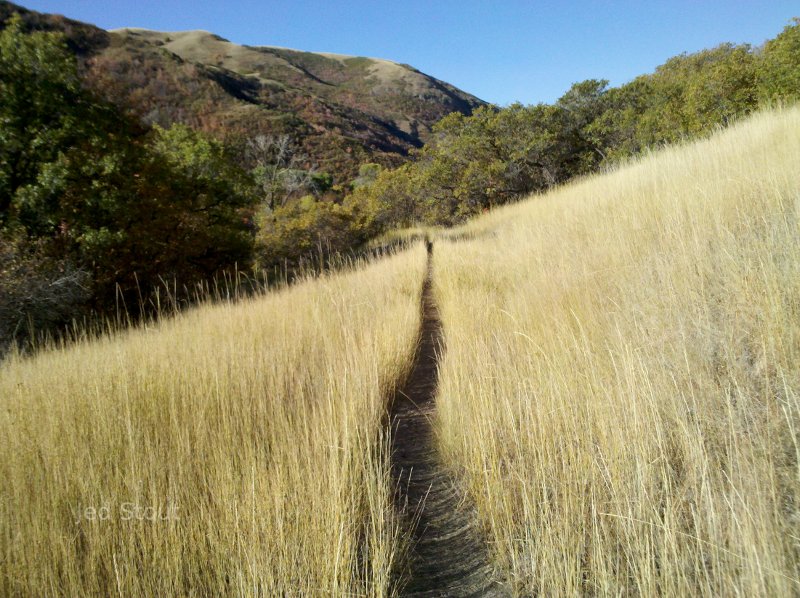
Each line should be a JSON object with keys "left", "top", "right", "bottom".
{"left": 434, "top": 109, "right": 800, "bottom": 596}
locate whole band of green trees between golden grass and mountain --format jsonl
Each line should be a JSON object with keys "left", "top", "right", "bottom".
{"left": 0, "top": 11, "right": 800, "bottom": 350}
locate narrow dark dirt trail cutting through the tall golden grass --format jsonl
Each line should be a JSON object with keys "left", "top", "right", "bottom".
{"left": 390, "top": 243, "right": 507, "bottom": 597}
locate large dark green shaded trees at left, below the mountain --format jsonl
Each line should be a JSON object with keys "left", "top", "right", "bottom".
{"left": 0, "top": 19, "right": 252, "bottom": 346}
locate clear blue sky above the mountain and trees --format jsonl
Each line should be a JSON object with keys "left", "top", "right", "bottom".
{"left": 14, "top": 0, "right": 800, "bottom": 105}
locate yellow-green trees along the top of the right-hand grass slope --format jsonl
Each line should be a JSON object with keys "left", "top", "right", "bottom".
{"left": 345, "top": 19, "right": 800, "bottom": 235}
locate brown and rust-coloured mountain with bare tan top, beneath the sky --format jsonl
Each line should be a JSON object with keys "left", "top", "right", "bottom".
{"left": 0, "top": 2, "right": 485, "bottom": 182}
